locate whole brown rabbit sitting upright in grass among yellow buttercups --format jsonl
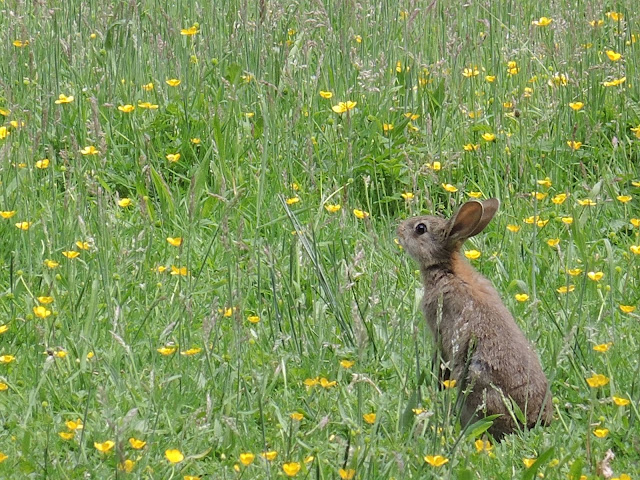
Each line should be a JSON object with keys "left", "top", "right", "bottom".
{"left": 398, "top": 198, "right": 553, "bottom": 440}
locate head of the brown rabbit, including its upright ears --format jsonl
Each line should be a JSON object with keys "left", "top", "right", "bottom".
{"left": 398, "top": 198, "right": 500, "bottom": 268}
